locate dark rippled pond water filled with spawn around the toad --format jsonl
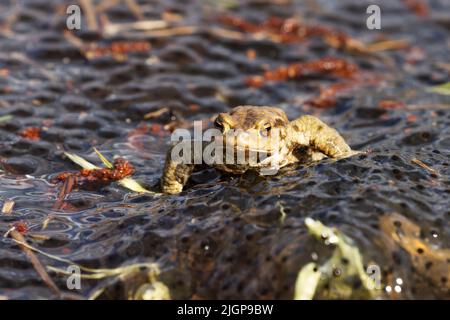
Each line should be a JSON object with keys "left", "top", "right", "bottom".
{"left": 0, "top": 0, "right": 450, "bottom": 299}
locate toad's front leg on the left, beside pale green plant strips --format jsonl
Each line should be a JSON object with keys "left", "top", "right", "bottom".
{"left": 161, "top": 146, "right": 194, "bottom": 194}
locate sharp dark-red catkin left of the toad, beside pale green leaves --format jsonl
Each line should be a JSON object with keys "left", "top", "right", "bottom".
{"left": 54, "top": 158, "right": 135, "bottom": 189}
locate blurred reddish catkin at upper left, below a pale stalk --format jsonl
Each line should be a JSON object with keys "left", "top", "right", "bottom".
{"left": 83, "top": 41, "right": 151, "bottom": 59}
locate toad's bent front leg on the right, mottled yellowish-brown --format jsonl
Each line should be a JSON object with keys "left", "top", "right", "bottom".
{"left": 288, "top": 115, "right": 357, "bottom": 158}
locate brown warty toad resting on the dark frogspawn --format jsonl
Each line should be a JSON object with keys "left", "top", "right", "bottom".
{"left": 161, "top": 106, "right": 357, "bottom": 194}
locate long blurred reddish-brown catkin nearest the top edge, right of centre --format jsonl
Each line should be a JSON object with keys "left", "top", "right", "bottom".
{"left": 219, "top": 15, "right": 363, "bottom": 49}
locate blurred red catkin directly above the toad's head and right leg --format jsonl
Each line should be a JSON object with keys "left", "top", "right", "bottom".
{"left": 246, "top": 57, "right": 358, "bottom": 88}
